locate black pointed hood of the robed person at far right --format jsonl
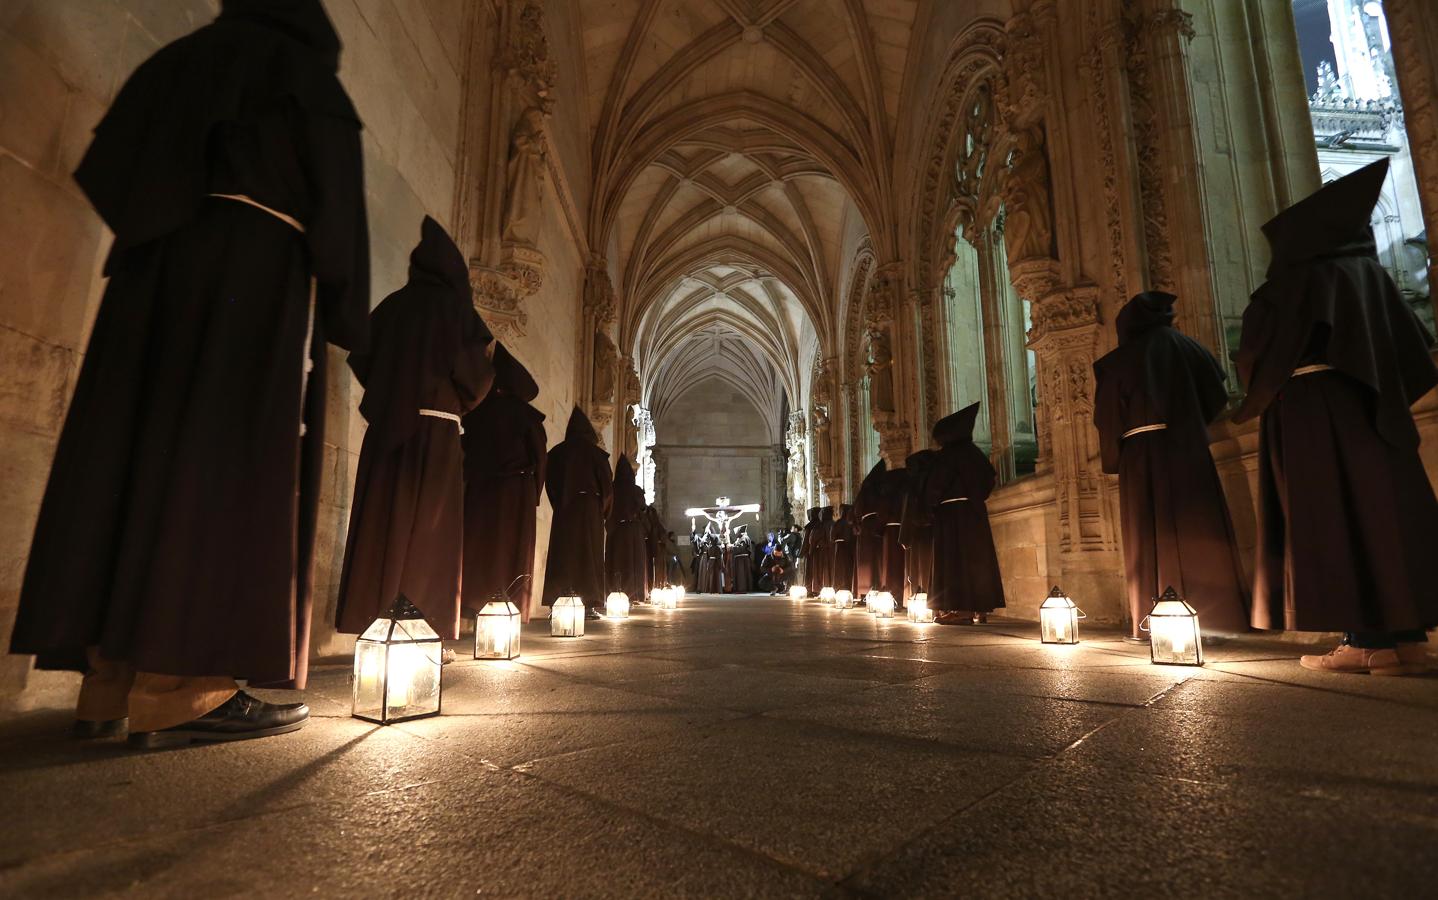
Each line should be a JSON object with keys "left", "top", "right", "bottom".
{"left": 1263, "top": 157, "right": 1388, "bottom": 279}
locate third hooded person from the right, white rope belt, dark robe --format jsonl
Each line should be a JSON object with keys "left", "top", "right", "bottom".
{"left": 923, "top": 404, "right": 1004, "bottom": 612}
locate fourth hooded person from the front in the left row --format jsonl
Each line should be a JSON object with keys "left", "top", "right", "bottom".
{"left": 544, "top": 407, "right": 614, "bottom": 610}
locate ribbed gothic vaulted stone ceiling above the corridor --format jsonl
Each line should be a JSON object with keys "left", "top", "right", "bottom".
{"left": 580, "top": 0, "right": 917, "bottom": 424}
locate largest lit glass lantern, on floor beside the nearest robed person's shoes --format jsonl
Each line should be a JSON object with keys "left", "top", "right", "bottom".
{"left": 351, "top": 595, "right": 444, "bottom": 725}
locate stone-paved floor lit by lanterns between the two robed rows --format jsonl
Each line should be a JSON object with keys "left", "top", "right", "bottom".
{"left": 0, "top": 598, "right": 1438, "bottom": 897}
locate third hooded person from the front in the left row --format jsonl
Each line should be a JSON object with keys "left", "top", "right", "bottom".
{"left": 460, "top": 344, "right": 548, "bottom": 621}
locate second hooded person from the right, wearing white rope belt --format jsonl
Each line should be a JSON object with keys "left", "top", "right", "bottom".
{"left": 1093, "top": 290, "right": 1248, "bottom": 637}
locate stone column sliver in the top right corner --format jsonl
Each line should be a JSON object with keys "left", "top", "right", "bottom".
{"left": 1383, "top": 0, "right": 1438, "bottom": 311}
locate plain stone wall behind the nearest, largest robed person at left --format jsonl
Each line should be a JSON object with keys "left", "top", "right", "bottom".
{"left": 0, "top": 0, "right": 477, "bottom": 706}
